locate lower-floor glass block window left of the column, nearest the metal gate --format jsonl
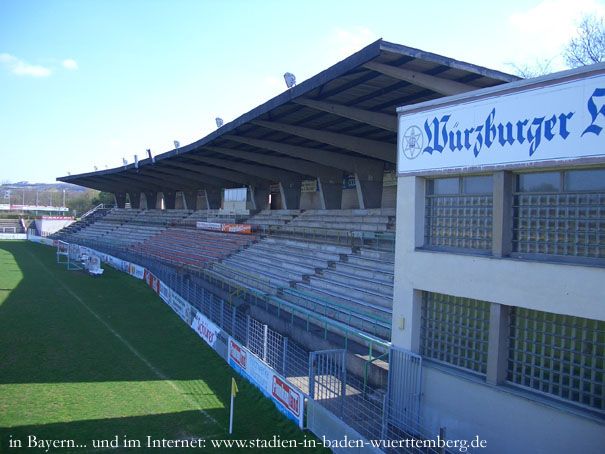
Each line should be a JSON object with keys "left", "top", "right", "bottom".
{"left": 420, "top": 292, "right": 490, "bottom": 374}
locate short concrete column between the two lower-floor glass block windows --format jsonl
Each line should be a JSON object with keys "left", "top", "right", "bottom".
{"left": 486, "top": 303, "right": 510, "bottom": 385}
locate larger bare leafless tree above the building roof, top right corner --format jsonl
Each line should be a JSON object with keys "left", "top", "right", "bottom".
{"left": 563, "top": 15, "right": 605, "bottom": 68}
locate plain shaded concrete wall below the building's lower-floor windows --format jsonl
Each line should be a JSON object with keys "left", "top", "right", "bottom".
{"left": 422, "top": 366, "right": 605, "bottom": 454}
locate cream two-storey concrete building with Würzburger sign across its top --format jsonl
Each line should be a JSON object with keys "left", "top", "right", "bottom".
{"left": 392, "top": 64, "right": 605, "bottom": 454}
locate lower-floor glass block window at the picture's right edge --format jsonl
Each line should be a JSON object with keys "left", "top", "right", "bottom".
{"left": 507, "top": 307, "right": 605, "bottom": 412}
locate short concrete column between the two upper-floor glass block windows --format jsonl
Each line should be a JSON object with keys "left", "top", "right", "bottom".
{"left": 492, "top": 172, "right": 513, "bottom": 257}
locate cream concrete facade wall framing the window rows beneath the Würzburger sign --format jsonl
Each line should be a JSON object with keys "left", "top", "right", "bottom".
{"left": 392, "top": 177, "right": 605, "bottom": 453}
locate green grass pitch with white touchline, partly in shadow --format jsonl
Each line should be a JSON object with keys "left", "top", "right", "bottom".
{"left": 0, "top": 241, "right": 329, "bottom": 453}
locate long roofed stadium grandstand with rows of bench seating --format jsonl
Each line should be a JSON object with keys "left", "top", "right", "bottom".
{"left": 47, "top": 40, "right": 602, "bottom": 453}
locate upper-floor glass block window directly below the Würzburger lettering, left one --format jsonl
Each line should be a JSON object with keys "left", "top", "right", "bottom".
{"left": 425, "top": 176, "right": 493, "bottom": 253}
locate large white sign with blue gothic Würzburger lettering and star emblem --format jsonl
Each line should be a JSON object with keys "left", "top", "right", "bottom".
{"left": 397, "top": 74, "right": 605, "bottom": 175}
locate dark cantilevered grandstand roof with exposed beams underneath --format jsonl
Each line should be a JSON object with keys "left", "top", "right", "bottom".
{"left": 57, "top": 40, "right": 518, "bottom": 192}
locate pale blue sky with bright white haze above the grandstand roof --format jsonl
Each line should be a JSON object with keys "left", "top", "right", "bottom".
{"left": 0, "top": 0, "right": 605, "bottom": 183}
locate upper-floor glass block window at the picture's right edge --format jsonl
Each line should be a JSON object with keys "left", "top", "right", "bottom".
{"left": 513, "top": 169, "right": 605, "bottom": 263}
